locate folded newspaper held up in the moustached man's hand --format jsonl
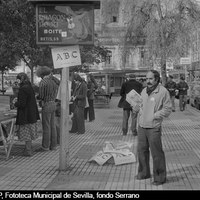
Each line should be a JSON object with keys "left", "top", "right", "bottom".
{"left": 126, "top": 89, "right": 142, "bottom": 112}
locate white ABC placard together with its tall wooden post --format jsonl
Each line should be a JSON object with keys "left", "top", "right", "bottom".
{"left": 51, "top": 45, "right": 81, "bottom": 171}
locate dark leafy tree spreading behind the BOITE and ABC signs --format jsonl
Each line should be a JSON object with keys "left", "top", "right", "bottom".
{"left": 0, "top": 0, "right": 108, "bottom": 82}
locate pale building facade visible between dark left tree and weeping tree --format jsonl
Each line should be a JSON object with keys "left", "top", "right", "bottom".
{"left": 90, "top": 0, "right": 149, "bottom": 93}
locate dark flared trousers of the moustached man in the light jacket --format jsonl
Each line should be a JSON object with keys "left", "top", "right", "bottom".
{"left": 137, "top": 126, "right": 167, "bottom": 183}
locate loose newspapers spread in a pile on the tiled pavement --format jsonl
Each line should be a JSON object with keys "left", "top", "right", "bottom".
{"left": 89, "top": 141, "right": 136, "bottom": 165}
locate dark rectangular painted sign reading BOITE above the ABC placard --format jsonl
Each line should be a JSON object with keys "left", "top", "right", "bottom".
{"left": 36, "top": 4, "right": 94, "bottom": 45}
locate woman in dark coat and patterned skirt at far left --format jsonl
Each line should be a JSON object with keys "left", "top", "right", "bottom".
{"left": 14, "top": 72, "right": 40, "bottom": 156}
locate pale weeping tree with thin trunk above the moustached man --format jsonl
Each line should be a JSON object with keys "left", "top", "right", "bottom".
{"left": 124, "top": 0, "right": 200, "bottom": 84}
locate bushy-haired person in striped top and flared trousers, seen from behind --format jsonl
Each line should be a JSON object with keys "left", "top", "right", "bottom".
{"left": 36, "top": 66, "right": 60, "bottom": 151}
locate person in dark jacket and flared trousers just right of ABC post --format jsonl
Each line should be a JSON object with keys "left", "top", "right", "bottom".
{"left": 69, "top": 74, "right": 87, "bottom": 134}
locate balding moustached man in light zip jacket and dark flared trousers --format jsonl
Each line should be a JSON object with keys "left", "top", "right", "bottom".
{"left": 136, "top": 70, "right": 172, "bottom": 185}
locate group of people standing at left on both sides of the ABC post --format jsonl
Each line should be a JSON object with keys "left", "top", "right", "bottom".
{"left": 13, "top": 66, "right": 97, "bottom": 156}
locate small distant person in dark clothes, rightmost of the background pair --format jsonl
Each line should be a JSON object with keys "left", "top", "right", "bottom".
{"left": 177, "top": 76, "right": 189, "bottom": 111}
